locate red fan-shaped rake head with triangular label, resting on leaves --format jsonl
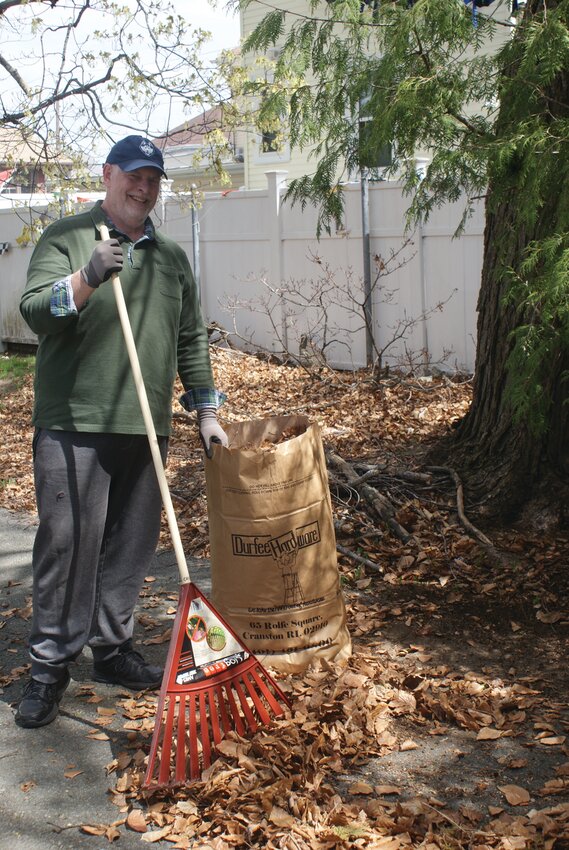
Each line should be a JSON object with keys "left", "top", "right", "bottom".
{"left": 143, "top": 584, "right": 290, "bottom": 788}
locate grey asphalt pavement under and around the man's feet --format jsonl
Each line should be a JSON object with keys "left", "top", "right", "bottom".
{"left": 0, "top": 509, "right": 211, "bottom": 850}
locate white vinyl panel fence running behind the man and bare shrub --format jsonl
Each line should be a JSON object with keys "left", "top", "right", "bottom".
{"left": 0, "top": 172, "right": 484, "bottom": 372}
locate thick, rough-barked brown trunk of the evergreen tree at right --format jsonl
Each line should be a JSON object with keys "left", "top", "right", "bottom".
{"left": 439, "top": 0, "right": 569, "bottom": 524}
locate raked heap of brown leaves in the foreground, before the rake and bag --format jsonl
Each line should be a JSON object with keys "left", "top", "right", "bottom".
{"left": 82, "top": 636, "right": 569, "bottom": 850}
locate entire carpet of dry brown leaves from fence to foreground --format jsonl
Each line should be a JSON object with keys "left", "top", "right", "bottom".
{"left": 0, "top": 349, "right": 569, "bottom": 850}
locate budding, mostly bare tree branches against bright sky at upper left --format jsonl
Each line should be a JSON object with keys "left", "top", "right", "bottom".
{"left": 0, "top": 0, "right": 237, "bottom": 193}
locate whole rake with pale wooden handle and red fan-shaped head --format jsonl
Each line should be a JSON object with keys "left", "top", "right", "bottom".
{"left": 101, "top": 225, "right": 290, "bottom": 789}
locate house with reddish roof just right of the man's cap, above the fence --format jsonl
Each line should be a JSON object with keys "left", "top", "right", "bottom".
{"left": 154, "top": 107, "right": 245, "bottom": 192}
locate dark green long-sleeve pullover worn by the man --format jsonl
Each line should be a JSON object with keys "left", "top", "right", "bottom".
{"left": 20, "top": 203, "right": 214, "bottom": 435}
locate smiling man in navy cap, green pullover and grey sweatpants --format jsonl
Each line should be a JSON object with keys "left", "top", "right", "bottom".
{"left": 16, "top": 136, "right": 227, "bottom": 728}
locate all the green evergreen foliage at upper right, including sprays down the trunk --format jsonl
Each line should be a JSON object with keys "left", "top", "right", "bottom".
{"left": 237, "top": 0, "right": 569, "bottom": 434}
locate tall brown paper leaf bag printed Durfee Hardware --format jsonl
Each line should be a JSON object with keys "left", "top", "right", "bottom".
{"left": 206, "top": 416, "right": 351, "bottom": 672}
